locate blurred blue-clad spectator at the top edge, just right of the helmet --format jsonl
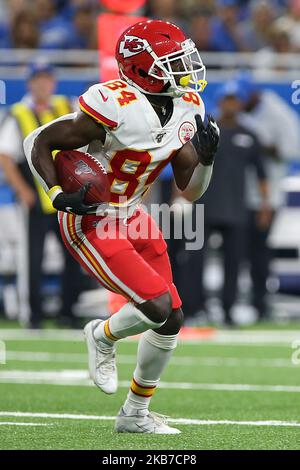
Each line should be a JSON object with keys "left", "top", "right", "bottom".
{"left": 211, "top": 0, "right": 247, "bottom": 52}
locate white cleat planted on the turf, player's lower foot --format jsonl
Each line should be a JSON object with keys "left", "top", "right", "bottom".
{"left": 115, "top": 408, "right": 181, "bottom": 434}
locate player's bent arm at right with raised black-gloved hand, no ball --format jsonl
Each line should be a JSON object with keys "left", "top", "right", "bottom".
{"left": 172, "top": 115, "right": 220, "bottom": 201}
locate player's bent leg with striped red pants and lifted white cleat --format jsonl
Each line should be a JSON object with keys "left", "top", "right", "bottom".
{"left": 60, "top": 214, "right": 171, "bottom": 393}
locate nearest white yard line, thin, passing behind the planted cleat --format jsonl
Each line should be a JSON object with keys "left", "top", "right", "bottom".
{"left": 0, "top": 411, "right": 300, "bottom": 427}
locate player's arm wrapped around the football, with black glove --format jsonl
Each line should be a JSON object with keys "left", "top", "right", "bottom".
{"left": 24, "top": 112, "right": 106, "bottom": 214}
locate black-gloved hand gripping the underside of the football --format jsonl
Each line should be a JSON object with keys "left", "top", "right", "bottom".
{"left": 52, "top": 183, "right": 98, "bottom": 215}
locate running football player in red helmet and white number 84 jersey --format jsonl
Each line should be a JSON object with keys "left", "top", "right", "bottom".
{"left": 24, "top": 20, "right": 219, "bottom": 434}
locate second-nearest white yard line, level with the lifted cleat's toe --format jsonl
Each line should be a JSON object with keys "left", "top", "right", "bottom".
{"left": 0, "top": 370, "right": 300, "bottom": 393}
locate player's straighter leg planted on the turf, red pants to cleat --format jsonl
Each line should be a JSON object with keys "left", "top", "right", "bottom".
{"left": 116, "top": 213, "right": 183, "bottom": 433}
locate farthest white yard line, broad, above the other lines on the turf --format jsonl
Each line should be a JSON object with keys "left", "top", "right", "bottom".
{"left": 0, "top": 328, "right": 300, "bottom": 346}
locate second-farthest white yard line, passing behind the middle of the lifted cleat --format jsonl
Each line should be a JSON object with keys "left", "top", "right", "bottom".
{"left": 6, "top": 351, "right": 296, "bottom": 368}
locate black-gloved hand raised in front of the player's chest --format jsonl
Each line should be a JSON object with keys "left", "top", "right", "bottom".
{"left": 192, "top": 114, "right": 220, "bottom": 166}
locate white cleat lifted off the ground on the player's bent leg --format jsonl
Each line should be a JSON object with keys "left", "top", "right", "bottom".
{"left": 84, "top": 320, "right": 118, "bottom": 394}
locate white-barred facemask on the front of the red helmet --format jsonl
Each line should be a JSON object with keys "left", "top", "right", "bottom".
{"left": 148, "top": 39, "right": 207, "bottom": 96}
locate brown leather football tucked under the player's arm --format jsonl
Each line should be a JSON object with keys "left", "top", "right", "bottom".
{"left": 54, "top": 150, "right": 110, "bottom": 204}
